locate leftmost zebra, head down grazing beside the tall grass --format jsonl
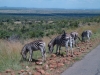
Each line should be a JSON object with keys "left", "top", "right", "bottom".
{"left": 21, "top": 40, "right": 46, "bottom": 61}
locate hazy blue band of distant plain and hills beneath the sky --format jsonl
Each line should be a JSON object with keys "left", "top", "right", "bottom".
{"left": 0, "top": 7, "right": 100, "bottom": 14}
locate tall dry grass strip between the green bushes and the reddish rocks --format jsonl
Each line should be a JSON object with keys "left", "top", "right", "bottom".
{"left": 0, "top": 23, "right": 100, "bottom": 72}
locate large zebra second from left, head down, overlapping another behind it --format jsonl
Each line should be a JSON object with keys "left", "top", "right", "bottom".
{"left": 48, "top": 32, "right": 74, "bottom": 56}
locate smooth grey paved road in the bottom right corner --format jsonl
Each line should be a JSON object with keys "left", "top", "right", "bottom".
{"left": 61, "top": 45, "right": 100, "bottom": 75}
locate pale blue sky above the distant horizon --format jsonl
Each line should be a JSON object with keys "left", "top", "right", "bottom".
{"left": 0, "top": 0, "right": 100, "bottom": 9}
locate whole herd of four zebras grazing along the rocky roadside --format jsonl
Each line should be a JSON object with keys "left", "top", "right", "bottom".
{"left": 21, "top": 30, "right": 92, "bottom": 61}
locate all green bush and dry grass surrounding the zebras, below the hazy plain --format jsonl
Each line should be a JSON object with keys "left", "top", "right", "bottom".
{"left": 0, "top": 14, "right": 100, "bottom": 75}
